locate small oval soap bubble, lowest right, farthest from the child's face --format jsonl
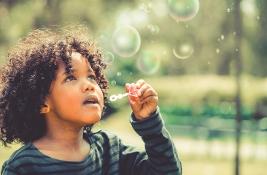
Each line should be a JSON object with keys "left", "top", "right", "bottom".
{"left": 172, "top": 44, "right": 194, "bottom": 59}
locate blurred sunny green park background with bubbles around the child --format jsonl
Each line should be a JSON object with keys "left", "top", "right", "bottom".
{"left": 0, "top": 0, "right": 267, "bottom": 175}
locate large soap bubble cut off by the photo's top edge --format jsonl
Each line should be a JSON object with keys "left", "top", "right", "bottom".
{"left": 168, "top": 0, "right": 199, "bottom": 21}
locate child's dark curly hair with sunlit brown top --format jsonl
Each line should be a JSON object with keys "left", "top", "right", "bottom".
{"left": 0, "top": 26, "right": 108, "bottom": 146}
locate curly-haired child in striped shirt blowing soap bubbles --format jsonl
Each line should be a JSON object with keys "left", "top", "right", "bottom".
{"left": 0, "top": 27, "right": 182, "bottom": 175}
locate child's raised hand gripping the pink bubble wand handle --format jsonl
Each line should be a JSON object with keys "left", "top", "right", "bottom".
{"left": 125, "top": 80, "right": 158, "bottom": 120}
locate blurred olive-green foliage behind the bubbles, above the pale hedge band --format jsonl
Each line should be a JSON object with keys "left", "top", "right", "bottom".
{"left": 0, "top": 0, "right": 267, "bottom": 78}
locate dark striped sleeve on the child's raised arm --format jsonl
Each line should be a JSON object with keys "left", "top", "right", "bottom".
{"left": 120, "top": 110, "right": 182, "bottom": 175}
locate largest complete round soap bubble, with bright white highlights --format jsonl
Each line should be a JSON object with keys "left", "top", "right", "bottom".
{"left": 112, "top": 25, "right": 141, "bottom": 57}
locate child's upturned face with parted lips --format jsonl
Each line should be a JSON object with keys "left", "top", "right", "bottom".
{"left": 44, "top": 52, "right": 104, "bottom": 126}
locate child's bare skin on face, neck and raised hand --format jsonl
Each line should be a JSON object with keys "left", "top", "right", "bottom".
{"left": 33, "top": 52, "right": 158, "bottom": 161}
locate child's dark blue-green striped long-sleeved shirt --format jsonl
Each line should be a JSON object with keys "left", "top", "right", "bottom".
{"left": 1, "top": 110, "right": 182, "bottom": 175}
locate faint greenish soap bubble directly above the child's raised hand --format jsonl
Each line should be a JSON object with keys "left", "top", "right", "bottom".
{"left": 137, "top": 51, "right": 160, "bottom": 75}
